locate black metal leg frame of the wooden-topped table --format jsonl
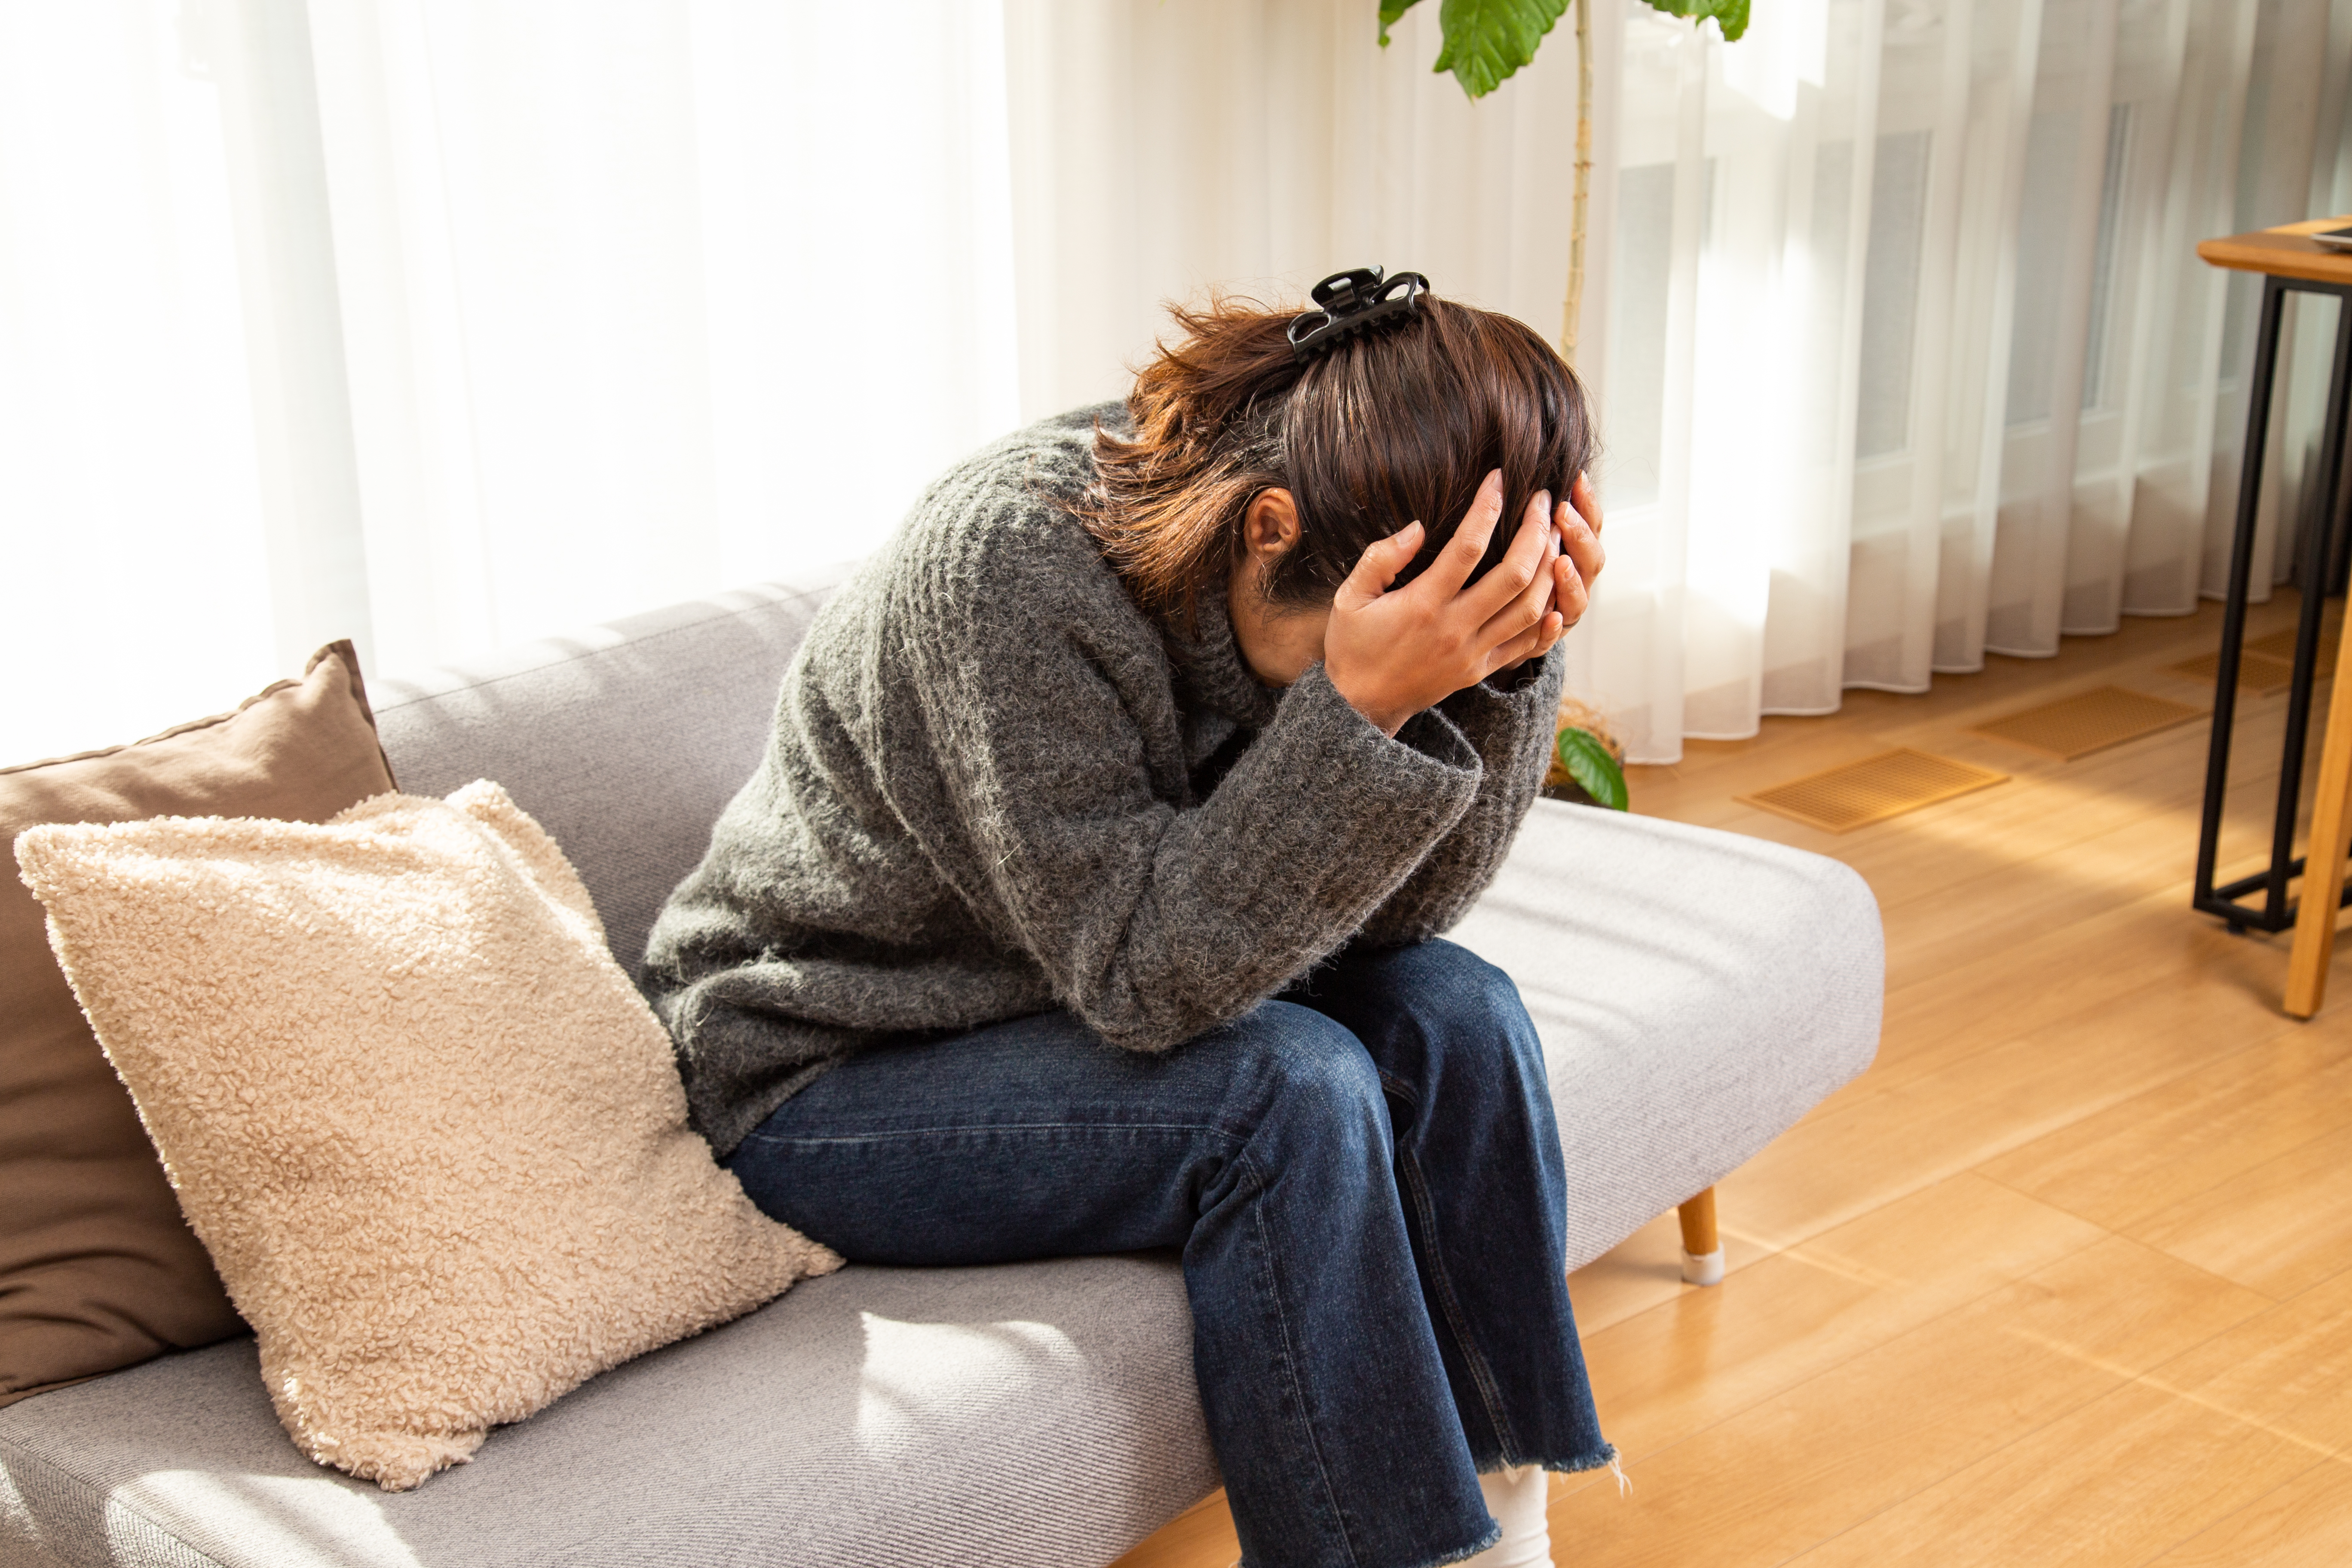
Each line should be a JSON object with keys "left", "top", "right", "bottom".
{"left": 2194, "top": 273, "right": 2352, "bottom": 931}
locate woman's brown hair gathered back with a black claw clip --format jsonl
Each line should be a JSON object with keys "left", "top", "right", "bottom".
{"left": 1080, "top": 285, "right": 1595, "bottom": 625}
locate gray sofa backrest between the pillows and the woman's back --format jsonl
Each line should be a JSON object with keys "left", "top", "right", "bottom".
{"left": 374, "top": 569, "right": 847, "bottom": 973}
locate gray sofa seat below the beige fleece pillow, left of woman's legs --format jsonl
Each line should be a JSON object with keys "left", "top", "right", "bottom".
{"left": 0, "top": 1256, "right": 1216, "bottom": 1568}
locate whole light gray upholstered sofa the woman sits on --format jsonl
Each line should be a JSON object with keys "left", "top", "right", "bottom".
{"left": 0, "top": 578, "right": 1882, "bottom": 1568}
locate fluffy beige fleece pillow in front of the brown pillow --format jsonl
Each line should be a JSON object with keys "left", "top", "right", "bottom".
{"left": 16, "top": 783, "right": 840, "bottom": 1491}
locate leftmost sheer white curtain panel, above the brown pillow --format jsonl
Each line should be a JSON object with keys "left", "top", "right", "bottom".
{"left": 0, "top": 5, "right": 278, "bottom": 762}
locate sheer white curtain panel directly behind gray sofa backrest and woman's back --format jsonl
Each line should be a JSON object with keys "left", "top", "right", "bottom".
{"left": 310, "top": 0, "right": 1018, "bottom": 668}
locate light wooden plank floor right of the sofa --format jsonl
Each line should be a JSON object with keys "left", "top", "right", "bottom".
{"left": 1122, "top": 595, "right": 2352, "bottom": 1568}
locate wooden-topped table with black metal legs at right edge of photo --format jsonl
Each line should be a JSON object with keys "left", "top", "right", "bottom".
{"left": 2194, "top": 219, "right": 2352, "bottom": 973}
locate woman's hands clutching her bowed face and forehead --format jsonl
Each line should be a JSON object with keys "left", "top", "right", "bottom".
{"left": 1324, "top": 470, "right": 1562, "bottom": 736}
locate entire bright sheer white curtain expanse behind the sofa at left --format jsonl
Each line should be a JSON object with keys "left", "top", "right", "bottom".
{"left": 0, "top": 0, "right": 1018, "bottom": 760}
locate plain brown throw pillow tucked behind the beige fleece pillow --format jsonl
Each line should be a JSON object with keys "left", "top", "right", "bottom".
{"left": 0, "top": 642, "right": 393, "bottom": 1406}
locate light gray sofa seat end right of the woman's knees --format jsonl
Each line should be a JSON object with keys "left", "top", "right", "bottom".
{"left": 1451, "top": 799, "right": 1886, "bottom": 1269}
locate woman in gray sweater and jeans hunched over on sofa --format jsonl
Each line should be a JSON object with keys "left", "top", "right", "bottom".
{"left": 647, "top": 268, "right": 1614, "bottom": 1568}
